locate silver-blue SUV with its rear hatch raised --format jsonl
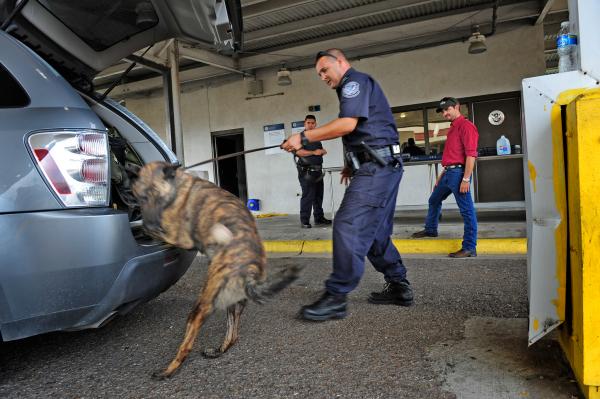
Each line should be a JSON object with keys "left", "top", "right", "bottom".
{"left": 0, "top": 0, "right": 241, "bottom": 341}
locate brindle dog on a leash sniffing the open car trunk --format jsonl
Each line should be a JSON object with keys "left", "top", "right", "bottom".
{"left": 133, "top": 162, "right": 298, "bottom": 379}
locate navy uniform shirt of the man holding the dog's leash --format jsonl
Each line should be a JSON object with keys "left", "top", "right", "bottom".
{"left": 336, "top": 68, "right": 398, "bottom": 151}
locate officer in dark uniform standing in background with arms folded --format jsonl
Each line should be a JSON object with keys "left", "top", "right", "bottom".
{"left": 294, "top": 115, "right": 331, "bottom": 229}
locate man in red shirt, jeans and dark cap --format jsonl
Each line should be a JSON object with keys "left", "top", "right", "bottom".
{"left": 412, "top": 97, "right": 479, "bottom": 258}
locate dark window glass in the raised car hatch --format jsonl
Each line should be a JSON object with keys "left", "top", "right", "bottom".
{"left": 38, "top": 0, "right": 158, "bottom": 51}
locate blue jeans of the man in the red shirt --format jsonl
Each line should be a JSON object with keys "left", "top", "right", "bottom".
{"left": 425, "top": 168, "right": 477, "bottom": 251}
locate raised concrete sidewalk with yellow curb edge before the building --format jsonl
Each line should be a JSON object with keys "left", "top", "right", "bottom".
{"left": 257, "top": 209, "right": 527, "bottom": 255}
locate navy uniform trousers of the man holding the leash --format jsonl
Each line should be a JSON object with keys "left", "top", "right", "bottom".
{"left": 325, "top": 162, "right": 406, "bottom": 294}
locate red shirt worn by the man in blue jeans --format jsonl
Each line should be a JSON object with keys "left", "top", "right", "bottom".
{"left": 442, "top": 115, "right": 479, "bottom": 166}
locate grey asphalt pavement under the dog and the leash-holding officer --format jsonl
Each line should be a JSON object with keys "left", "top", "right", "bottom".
{"left": 0, "top": 256, "right": 578, "bottom": 399}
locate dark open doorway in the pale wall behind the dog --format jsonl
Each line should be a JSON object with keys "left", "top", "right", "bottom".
{"left": 212, "top": 129, "right": 248, "bottom": 203}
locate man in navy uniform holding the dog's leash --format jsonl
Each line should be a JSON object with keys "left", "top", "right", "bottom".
{"left": 282, "top": 49, "right": 413, "bottom": 320}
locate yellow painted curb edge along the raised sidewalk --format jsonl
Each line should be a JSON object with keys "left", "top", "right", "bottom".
{"left": 263, "top": 238, "right": 527, "bottom": 255}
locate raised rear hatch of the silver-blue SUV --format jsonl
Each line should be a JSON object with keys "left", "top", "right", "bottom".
{"left": 0, "top": 0, "right": 242, "bottom": 91}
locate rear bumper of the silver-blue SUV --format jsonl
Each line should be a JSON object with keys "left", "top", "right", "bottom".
{"left": 0, "top": 208, "right": 196, "bottom": 341}
